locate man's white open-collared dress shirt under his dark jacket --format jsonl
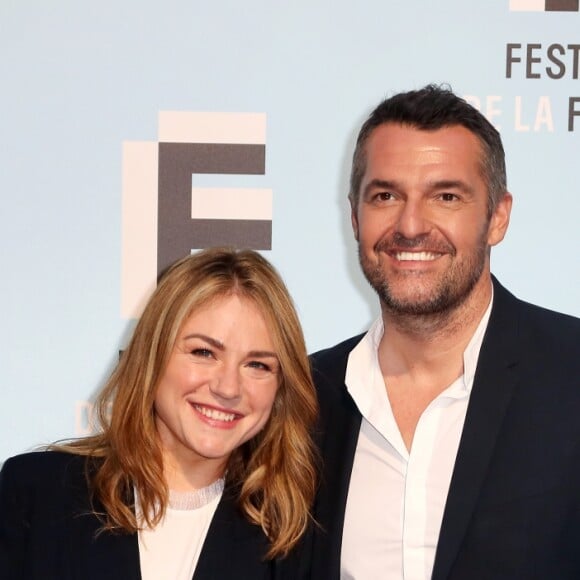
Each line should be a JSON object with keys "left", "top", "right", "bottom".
{"left": 341, "top": 302, "right": 491, "bottom": 580}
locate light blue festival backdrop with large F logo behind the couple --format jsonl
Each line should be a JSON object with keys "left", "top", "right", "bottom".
{"left": 0, "top": 0, "right": 580, "bottom": 462}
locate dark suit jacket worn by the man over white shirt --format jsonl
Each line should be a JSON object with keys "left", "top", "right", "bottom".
{"left": 310, "top": 280, "right": 580, "bottom": 580}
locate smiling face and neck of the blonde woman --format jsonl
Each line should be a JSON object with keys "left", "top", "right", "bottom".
{"left": 155, "top": 294, "right": 280, "bottom": 483}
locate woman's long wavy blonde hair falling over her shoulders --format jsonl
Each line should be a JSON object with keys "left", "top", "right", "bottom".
{"left": 53, "top": 248, "right": 317, "bottom": 558}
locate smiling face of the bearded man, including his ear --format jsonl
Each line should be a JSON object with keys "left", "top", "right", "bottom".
{"left": 352, "top": 123, "right": 511, "bottom": 315}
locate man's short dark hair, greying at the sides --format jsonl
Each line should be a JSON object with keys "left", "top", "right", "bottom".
{"left": 348, "top": 85, "right": 507, "bottom": 215}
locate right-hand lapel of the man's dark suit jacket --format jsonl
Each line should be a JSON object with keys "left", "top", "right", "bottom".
{"left": 432, "top": 279, "right": 519, "bottom": 580}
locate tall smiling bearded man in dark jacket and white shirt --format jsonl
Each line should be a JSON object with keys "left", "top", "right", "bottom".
{"left": 311, "top": 86, "right": 580, "bottom": 580}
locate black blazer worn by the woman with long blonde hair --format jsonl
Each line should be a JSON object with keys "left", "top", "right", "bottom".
{"left": 0, "top": 451, "right": 295, "bottom": 580}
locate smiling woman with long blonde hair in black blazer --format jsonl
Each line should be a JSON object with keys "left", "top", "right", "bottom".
{"left": 0, "top": 249, "right": 316, "bottom": 580}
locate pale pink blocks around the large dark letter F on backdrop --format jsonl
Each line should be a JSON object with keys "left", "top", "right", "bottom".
{"left": 121, "top": 111, "right": 272, "bottom": 318}
